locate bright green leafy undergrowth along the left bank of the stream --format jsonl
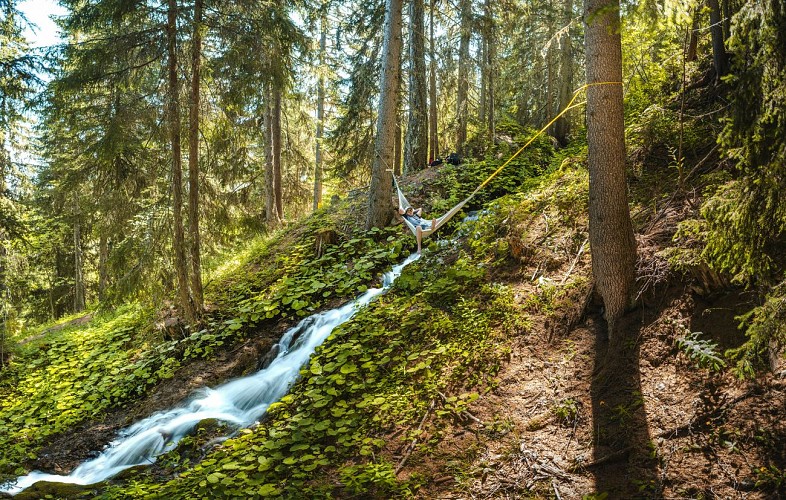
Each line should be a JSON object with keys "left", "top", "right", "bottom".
{"left": 0, "top": 206, "right": 410, "bottom": 480}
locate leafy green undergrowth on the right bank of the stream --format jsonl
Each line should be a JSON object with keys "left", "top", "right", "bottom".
{"left": 99, "top": 244, "right": 525, "bottom": 498}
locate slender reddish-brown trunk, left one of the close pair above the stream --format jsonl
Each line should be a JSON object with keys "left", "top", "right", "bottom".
{"left": 166, "top": 0, "right": 195, "bottom": 323}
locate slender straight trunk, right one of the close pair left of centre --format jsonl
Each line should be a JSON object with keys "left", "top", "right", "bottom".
{"left": 188, "top": 0, "right": 203, "bottom": 315}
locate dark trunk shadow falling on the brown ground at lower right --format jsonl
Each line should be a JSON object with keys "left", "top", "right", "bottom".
{"left": 586, "top": 310, "right": 661, "bottom": 499}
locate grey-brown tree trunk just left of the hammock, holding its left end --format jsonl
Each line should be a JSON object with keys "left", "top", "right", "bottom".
{"left": 366, "top": 0, "right": 402, "bottom": 229}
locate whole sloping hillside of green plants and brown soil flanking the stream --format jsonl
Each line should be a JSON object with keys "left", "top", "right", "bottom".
{"left": 0, "top": 124, "right": 786, "bottom": 498}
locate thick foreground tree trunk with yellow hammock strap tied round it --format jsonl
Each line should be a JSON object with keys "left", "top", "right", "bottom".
{"left": 584, "top": 0, "right": 636, "bottom": 340}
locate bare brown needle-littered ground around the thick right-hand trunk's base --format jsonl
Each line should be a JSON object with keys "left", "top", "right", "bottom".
{"left": 401, "top": 194, "right": 786, "bottom": 499}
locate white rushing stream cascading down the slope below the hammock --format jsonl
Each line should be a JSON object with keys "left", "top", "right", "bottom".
{"left": 0, "top": 254, "right": 420, "bottom": 494}
